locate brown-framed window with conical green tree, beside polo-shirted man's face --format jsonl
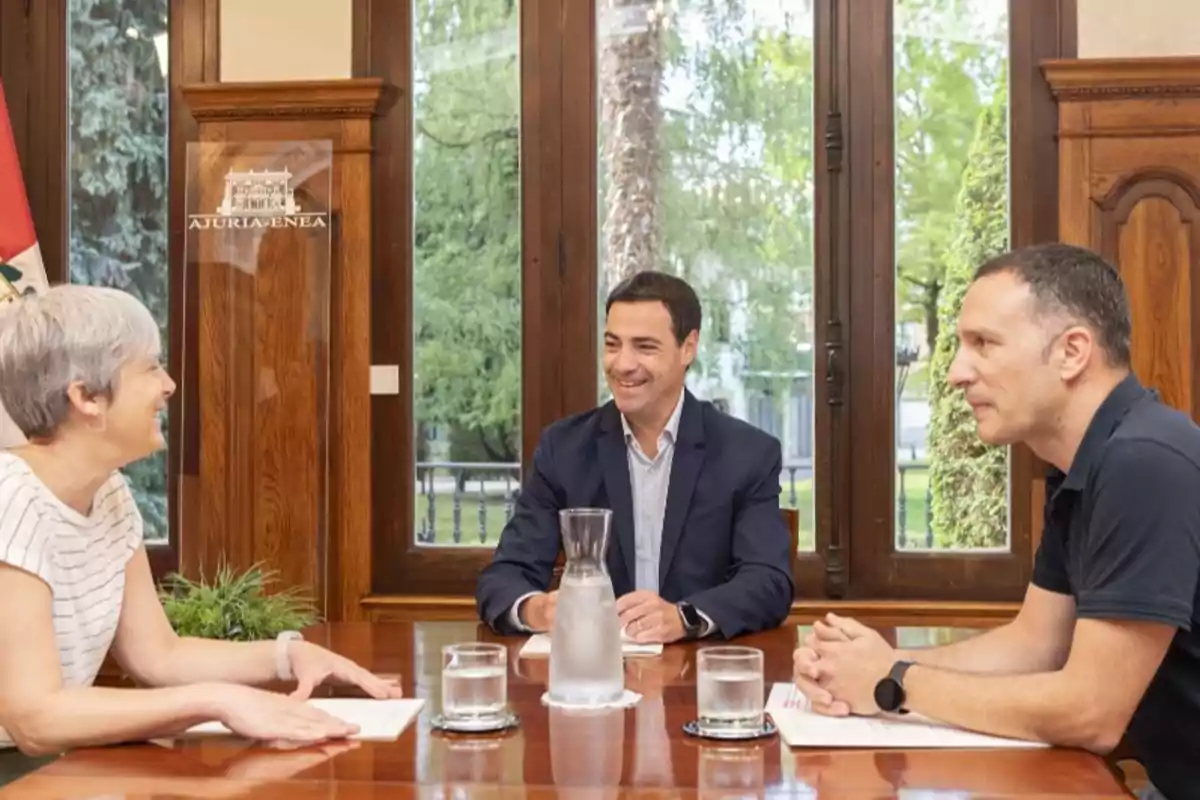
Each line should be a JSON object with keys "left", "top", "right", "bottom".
{"left": 844, "top": 0, "right": 1057, "bottom": 600}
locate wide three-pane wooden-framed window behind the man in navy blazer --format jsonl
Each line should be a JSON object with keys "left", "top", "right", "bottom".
{"left": 356, "top": 0, "right": 1074, "bottom": 600}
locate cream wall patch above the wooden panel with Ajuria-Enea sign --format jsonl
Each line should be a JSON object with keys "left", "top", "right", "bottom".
{"left": 221, "top": 0, "right": 350, "bottom": 82}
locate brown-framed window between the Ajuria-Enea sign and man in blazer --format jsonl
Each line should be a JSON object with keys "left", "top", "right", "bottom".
{"left": 369, "top": 0, "right": 535, "bottom": 593}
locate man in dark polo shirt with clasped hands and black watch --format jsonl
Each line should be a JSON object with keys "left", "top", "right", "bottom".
{"left": 796, "top": 245, "right": 1200, "bottom": 800}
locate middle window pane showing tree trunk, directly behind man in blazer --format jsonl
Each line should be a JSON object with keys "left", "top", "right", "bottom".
{"left": 595, "top": 0, "right": 815, "bottom": 551}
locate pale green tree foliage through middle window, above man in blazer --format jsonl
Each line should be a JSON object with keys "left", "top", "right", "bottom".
{"left": 619, "top": 0, "right": 814, "bottom": 397}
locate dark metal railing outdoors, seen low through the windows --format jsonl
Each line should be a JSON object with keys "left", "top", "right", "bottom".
{"left": 416, "top": 459, "right": 934, "bottom": 549}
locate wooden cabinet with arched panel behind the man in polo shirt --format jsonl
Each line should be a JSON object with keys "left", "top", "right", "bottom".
{"left": 1043, "top": 58, "right": 1200, "bottom": 419}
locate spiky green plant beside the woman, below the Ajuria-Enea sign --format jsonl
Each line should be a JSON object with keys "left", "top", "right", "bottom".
{"left": 158, "top": 564, "right": 318, "bottom": 642}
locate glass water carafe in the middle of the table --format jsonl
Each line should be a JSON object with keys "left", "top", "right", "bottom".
{"left": 550, "top": 509, "right": 625, "bottom": 705}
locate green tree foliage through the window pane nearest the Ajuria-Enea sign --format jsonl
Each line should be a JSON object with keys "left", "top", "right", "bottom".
{"left": 413, "top": 0, "right": 521, "bottom": 462}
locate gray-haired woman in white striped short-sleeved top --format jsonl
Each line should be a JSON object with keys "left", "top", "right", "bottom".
{"left": 0, "top": 285, "right": 400, "bottom": 754}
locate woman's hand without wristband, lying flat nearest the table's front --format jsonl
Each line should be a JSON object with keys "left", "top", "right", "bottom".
{"left": 220, "top": 685, "right": 359, "bottom": 744}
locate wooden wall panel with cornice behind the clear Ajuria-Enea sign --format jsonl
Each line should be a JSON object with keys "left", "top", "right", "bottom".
{"left": 182, "top": 79, "right": 383, "bottom": 620}
